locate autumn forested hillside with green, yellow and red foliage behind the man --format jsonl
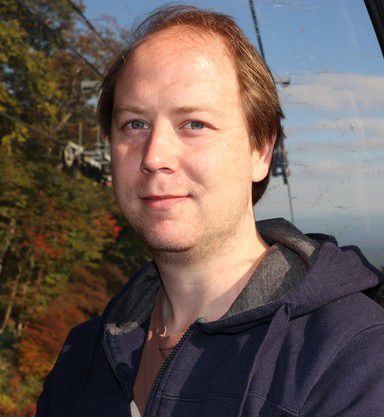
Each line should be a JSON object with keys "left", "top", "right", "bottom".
{"left": 0, "top": 0, "right": 148, "bottom": 417}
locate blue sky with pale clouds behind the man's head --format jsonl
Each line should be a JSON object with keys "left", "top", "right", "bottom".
{"left": 84, "top": 0, "right": 384, "bottom": 268}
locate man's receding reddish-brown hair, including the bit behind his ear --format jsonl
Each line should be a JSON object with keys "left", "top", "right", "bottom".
{"left": 97, "top": 6, "right": 284, "bottom": 204}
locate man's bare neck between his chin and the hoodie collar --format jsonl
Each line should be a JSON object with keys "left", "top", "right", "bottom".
{"left": 155, "top": 217, "right": 268, "bottom": 333}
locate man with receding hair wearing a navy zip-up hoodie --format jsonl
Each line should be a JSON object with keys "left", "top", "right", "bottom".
{"left": 37, "top": 6, "right": 384, "bottom": 417}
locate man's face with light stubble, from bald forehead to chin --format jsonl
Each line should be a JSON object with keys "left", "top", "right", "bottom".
{"left": 111, "top": 28, "right": 268, "bottom": 258}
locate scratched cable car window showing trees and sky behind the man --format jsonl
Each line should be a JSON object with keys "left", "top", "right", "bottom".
{"left": 0, "top": 0, "right": 384, "bottom": 415}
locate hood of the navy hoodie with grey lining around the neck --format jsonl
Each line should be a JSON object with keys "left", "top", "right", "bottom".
{"left": 105, "top": 218, "right": 383, "bottom": 335}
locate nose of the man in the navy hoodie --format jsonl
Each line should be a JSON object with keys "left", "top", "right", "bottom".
{"left": 140, "top": 126, "right": 178, "bottom": 174}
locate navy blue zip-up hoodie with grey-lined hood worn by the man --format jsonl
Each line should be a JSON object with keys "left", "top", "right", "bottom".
{"left": 36, "top": 220, "right": 384, "bottom": 417}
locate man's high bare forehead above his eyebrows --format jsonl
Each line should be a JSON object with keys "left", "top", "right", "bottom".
{"left": 116, "top": 26, "right": 238, "bottom": 98}
